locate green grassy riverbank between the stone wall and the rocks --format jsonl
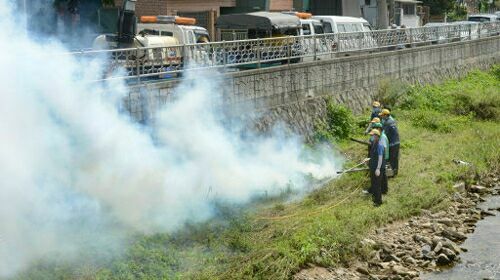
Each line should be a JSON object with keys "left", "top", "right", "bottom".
{"left": 16, "top": 67, "right": 500, "bottom": 279}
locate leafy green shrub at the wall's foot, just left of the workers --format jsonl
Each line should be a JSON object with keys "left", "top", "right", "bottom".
{"left": 314, "top": 99, "right": 354, "bottom": 142}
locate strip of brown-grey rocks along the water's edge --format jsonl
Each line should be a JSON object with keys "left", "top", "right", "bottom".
{"left": 294, "top": 174, "right": 500, "bottom": 280}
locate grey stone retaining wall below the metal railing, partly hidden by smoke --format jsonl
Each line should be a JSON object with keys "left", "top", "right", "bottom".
{"left": 125, "top": 36, "right": 500, "bottom": 135}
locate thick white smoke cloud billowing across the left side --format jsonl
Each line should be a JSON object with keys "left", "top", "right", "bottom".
{"left": 0, "top": 0, "right": 338, "bottom": 277}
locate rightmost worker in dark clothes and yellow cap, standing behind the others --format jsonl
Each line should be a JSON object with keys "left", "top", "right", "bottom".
{"left": 380, "top": 109, "right": 400, "bottom": 176}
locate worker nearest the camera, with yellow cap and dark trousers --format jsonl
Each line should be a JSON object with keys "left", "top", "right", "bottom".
{"left": 368, "top": 129, "right": 386, "bottom": 207}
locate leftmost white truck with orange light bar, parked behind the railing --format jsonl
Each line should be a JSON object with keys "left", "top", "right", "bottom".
{"left": 93, "top": 0, "right": 209, "bottom": 77}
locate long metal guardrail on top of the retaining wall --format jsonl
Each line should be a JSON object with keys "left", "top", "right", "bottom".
{"left": 71, "top": 22, "right": 500, "bottom": 81}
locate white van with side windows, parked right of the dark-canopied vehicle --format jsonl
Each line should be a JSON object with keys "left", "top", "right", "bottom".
{"left": 313, "top": 16, "right": 378, "bottom": 52}
